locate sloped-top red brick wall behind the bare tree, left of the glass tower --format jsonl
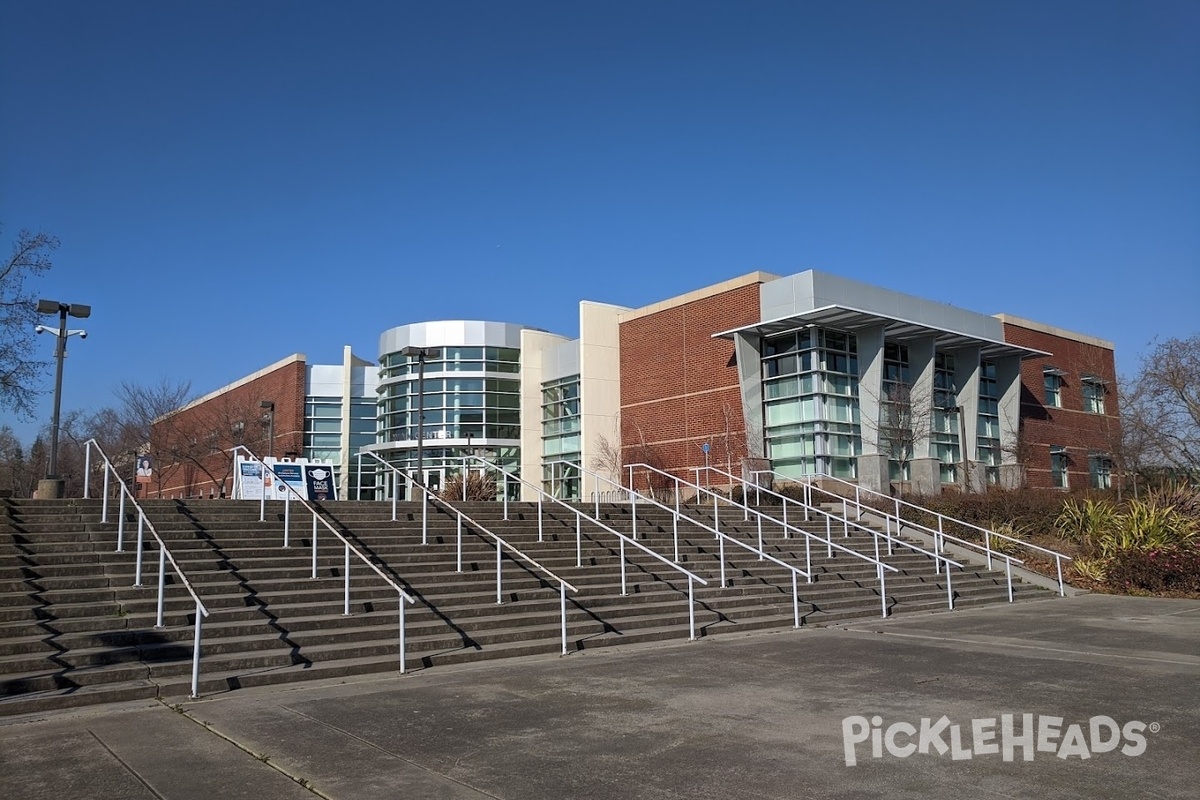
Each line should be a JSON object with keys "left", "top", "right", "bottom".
{"left": 146, "top": 360, "right": 306, "bottom": 498}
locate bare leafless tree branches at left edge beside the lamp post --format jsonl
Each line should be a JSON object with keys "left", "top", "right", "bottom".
{"left": 0, "top": 221, "right": 59, "bottom": 419}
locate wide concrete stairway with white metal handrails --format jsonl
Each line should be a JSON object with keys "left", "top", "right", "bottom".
{"left": 0, "top": 500, "right": 1048, "bottom": 715}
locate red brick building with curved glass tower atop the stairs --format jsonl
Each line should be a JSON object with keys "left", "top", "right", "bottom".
{"left": 156, "top": 270, "right": 1120, "bottom": 499}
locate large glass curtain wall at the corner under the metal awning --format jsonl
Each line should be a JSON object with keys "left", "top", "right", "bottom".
{"left": 762, "top": 329, "right": 862, "bottom": 479}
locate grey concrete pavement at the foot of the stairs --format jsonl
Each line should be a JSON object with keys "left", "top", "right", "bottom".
{"left": 0, "top": 595, "right": 1200, "bottom": 800}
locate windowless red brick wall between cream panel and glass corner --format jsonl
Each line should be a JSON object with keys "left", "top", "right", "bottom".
{"left": 620, "top": 283, "right": 760, "bottom": 475}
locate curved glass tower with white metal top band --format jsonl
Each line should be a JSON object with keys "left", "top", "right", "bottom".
{"left": 364, "top": 320, "right": 527, "bottom": 492}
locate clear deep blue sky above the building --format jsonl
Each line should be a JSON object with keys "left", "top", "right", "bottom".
{"left": 0, "top": 0, "right": 1200, "bottom": 443}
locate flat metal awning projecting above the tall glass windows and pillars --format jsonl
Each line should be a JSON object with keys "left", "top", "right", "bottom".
{"left": 713, "top": 305, "right": 1050, "bottom": 359}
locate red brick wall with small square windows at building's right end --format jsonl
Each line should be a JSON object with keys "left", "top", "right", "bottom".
{"left": 1004, "top": 323, "right": 1121, "bottom": 488}
